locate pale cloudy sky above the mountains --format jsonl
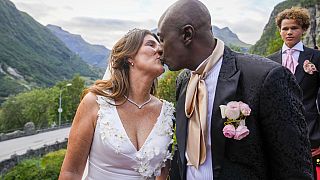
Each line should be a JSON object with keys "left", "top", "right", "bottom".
{"left": 11, "top": 0, "right": 283, "bottom": 49}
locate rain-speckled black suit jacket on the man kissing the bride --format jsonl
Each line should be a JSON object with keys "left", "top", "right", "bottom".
{"left": 170, "top": 47, "right": 313, "bottom": 180}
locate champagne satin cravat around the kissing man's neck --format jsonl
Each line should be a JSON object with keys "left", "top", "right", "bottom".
{"left": 185, "top": 39, "right": 224, "bottom": 169}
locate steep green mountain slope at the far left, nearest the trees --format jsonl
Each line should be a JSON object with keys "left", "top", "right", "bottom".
{"left": 0, "top": 0, "right": 101, "bottom": 102}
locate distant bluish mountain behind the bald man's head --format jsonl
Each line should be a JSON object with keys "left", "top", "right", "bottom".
{"left": 151, "top": 26, "right": 251, "bottom": 51}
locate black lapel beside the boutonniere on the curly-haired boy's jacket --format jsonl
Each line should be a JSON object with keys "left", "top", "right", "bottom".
{"left": 294, "top": 46, "right": 312, "bottom": 84}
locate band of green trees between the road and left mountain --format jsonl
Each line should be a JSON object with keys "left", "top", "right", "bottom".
{"left": 0, "top": 75, "right": 85, "bottom": 132}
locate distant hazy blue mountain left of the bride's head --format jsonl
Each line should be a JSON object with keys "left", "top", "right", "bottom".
{"left": 46, "top": 24, "right": 110, "bottom": 68}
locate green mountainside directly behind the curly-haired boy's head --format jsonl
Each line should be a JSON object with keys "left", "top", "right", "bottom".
{"left": 250, "top": 0, "right": 320, "bottom": 56}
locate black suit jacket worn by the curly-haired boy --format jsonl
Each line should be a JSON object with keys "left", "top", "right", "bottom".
{"left": 268, "top": 46, "right": 320, "bottom": 148}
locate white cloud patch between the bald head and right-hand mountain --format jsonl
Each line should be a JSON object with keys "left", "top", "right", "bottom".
{"left": 207, "top": 0, "right": 280, "bottom": 44}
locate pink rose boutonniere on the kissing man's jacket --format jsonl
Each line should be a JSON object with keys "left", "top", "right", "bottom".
{"left": 220, "top": 101, "right": 251, "bottom": 140}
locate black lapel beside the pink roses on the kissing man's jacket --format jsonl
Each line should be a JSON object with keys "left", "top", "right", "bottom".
{"left": 211, "top": 47, "right": 240, "bottom": 177}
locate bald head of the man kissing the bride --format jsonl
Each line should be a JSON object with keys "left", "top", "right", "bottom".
{"left": 158, "top": 0, "right": 215, "bottom": 70}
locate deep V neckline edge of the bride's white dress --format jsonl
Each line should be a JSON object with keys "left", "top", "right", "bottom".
{"left": 114, "top": 101, "right": 165, "bottom": 153}
